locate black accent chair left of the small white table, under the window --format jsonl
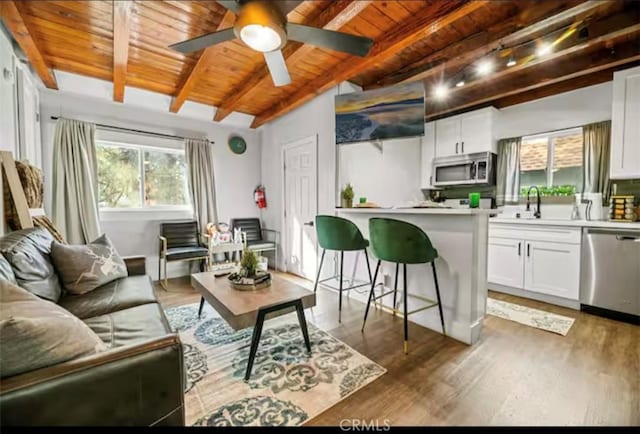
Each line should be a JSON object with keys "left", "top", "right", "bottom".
{"left": 158, "top": 220, "right": 209, "bottom": 289}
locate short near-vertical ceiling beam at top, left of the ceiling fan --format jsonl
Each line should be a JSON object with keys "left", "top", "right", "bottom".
{"left": 113, "top": 0, "right": 133, "bottom": 102}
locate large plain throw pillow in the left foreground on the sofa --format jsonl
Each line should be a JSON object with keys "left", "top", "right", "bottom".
{"left": 0, "top": 281, "right": 107, "bottom": 378}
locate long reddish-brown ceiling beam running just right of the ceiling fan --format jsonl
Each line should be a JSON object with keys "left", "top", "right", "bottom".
{"left": 251, "top": 0, "right": 490, "bottom": 128}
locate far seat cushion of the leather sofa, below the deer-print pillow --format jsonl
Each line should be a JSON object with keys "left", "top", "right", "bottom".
{"left": 59, "top": 276, "right": 157, "bottom": 319}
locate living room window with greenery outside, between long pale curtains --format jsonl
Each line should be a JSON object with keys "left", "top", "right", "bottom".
{"left": 96, "top": 142, "right": 189, "bottom": 209}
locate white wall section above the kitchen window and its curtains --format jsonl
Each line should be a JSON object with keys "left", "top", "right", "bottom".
{"left": 497, "top": 81, "right": 613, "bottom": 138}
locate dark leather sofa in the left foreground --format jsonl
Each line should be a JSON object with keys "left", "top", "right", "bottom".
{"left": 0, "top": 229, "right": 185, "bottom": 426}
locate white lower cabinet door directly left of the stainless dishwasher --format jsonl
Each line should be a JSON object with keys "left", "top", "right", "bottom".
{"left": 524, "top": 241, "right": 580, "bottom": 300}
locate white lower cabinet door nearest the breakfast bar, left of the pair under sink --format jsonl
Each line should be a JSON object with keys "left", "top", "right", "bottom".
{"left": 487, "top": 237, "right": 524, "bottom": 288}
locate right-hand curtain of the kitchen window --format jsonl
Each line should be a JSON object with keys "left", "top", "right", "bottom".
{"left": 582, "top": 121, "right": 612, "bottom": 203}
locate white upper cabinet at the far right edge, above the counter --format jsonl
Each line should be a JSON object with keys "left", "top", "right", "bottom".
{"left": 610, "top": 66, "right": 640, "bottom": 179}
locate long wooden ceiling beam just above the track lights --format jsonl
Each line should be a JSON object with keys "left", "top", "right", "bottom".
{"left": 364, "top": 0, "right": 621, "bottom": 89}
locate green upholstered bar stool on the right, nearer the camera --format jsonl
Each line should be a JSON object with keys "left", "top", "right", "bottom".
{"left": 362, "top": 218, "right": 446, "bottom": 354}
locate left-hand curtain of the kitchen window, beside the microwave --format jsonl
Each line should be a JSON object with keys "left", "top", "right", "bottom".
{"left": 496, "top": 137, "right": 522, "bottom": 205}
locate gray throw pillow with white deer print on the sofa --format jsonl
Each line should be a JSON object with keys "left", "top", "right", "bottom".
{"left": 51, "top": 234, "right": 128, "bottom": 295}
